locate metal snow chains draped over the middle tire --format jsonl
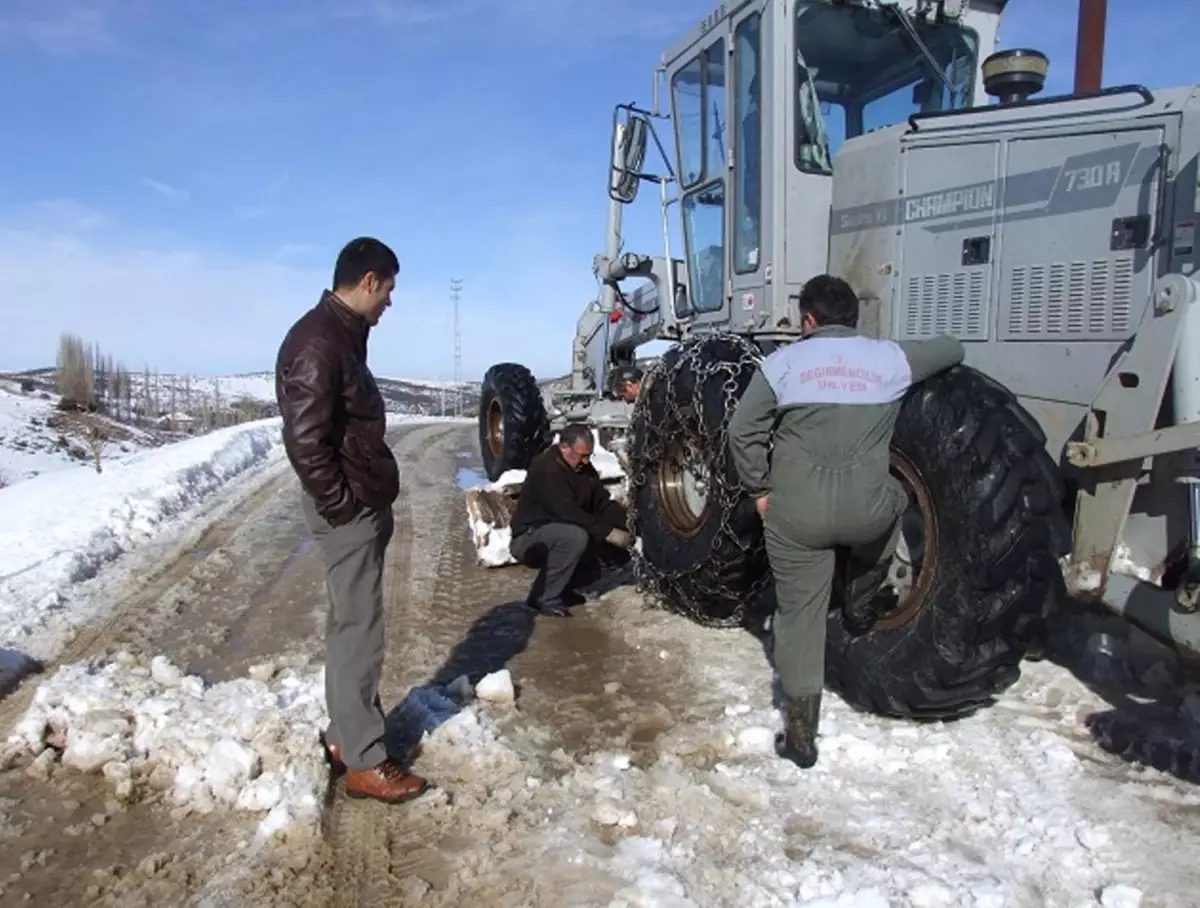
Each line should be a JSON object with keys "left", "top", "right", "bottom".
{"left": 629, "top": 333, "right": 770, "bottom": 627}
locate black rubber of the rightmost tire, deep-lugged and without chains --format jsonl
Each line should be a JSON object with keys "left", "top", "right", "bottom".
{"left": 826, "top": 366, "right": 1069, "bottom": 720}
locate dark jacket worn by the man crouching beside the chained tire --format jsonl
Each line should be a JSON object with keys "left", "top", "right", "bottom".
{"left": 512, "top": 445, "right": 628, "bottom": 540}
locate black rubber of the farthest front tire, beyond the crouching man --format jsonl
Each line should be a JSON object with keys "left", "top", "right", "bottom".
{"left": 479, "top": 362, "right": 551, "bottom": 482}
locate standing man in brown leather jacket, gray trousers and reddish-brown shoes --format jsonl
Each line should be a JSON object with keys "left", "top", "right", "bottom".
{"left": 275, "top": 237, "right": 428, "bottom": 804}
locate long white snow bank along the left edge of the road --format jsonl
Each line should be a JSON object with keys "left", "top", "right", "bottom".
{"left": 0, "top": 419, "right": 283, "bottom": 651}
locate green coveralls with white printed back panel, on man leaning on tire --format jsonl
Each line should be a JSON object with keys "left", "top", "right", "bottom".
{"left": 730, "top": 325, "right": 964, "bottom": 697}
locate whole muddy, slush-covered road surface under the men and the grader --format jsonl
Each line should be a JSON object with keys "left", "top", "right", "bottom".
{"left": 0, "top": 423, "right": 1200, "bottom": 908}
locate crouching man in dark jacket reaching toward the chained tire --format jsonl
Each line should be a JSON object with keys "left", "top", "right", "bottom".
{"left": 509, "top": 423, "right": 632, "bottom": 617}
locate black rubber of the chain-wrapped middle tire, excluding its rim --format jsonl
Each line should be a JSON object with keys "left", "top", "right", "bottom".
{"left": 630, "top": 335, "right": 770, "bottom": 627}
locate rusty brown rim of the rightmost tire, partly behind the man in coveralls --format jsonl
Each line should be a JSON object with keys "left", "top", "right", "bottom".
{"left": 875, "top": 451, "right": 937, "bottom": 631}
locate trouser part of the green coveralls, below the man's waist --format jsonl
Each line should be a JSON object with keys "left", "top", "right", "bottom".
{"left": 763, "top": 464, "right": 907, "bottom": 697}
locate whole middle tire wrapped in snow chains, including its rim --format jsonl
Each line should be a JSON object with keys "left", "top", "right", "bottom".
{"left": 629, "top": 335, "right": 770, "bottom": 627}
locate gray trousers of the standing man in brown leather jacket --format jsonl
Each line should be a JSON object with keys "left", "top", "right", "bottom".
{"left": 300, "top": 493, "right": 395, "bottom": 770}
